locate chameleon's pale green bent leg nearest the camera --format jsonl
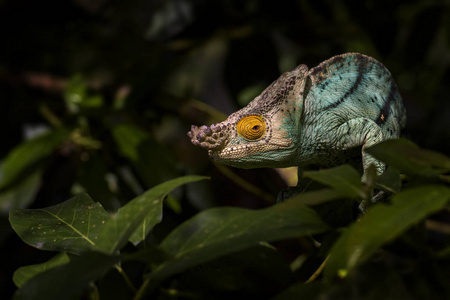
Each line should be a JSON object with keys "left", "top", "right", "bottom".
{"left": 329, "top": 118, "right": 386, "bottom": 181}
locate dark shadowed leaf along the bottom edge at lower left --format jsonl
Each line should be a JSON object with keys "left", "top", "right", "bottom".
{"left": 13, "top": 252, "right": 120, "bottom": 300}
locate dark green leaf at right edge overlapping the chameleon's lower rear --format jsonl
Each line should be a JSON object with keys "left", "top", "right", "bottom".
{"left": 366, "top": 139, "right": 450, "bottom": 176}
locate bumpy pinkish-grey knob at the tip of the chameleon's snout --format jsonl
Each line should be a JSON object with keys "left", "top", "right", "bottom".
{"left": 187, "top": 123, "right": 226, "bottom": 150}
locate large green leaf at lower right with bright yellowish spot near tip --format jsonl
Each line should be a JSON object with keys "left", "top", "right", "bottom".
{"left": 325, "top": 185, "right": 450, "bottom": 277}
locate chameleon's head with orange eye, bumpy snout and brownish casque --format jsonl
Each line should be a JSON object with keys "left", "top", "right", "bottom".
{"left": 188, "top": 65, "right": 307, "bottom": 168}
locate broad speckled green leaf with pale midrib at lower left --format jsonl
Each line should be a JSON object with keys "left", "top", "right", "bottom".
{"left": 9, "top": 194, "right": 109, "bottom": 254}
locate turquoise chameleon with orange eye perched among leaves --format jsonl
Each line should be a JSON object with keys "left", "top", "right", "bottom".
{"left": 188, "top": 53, "right": 406, "bottom": 203}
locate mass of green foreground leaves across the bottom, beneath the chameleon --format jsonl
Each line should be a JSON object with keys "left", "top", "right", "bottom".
{"left": 7, "top": 140, "right": 450, "bottom": 299}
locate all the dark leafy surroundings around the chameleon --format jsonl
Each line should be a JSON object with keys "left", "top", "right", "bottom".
{"left": 0, "top": 0, "right": 450, "bottom": 299}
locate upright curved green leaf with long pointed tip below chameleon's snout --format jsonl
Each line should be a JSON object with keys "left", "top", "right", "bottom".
{"left": 95, "top": 176, "right": 207, "bottom": 253}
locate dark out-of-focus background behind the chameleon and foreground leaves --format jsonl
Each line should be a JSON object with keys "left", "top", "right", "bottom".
{"left": 0, "top": 0, "right": 450, "bottom": 297}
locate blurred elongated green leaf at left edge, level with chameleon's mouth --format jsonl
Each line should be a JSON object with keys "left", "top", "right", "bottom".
{"left": 0, "top": 128, "right": 69, "bottom": 189}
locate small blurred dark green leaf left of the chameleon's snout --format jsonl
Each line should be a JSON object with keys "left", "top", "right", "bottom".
{"left": 112, "top": 124, "right": 149, "bottom": 162}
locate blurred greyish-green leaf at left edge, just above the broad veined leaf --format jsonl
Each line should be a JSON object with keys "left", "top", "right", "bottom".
{"left": 0, "top": 169, "right": 42, "bottom": 214}
